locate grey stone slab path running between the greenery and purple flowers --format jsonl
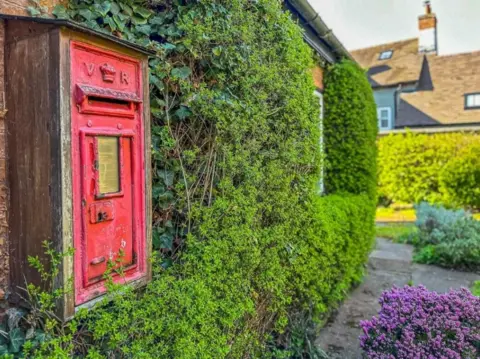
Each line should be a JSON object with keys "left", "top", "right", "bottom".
{"left": 317, "top": 238, "right": 480, "bottom": 359}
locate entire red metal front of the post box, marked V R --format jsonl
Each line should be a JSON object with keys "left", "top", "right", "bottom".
{"left": 70, "top": 41, "right": 147, "bottom": 305}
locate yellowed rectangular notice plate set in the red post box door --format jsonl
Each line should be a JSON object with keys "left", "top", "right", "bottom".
{"left": 97, "top": 136, "right": 120, "bottom": 194}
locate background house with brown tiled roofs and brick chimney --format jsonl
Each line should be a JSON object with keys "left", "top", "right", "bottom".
{"left": 352, "top": 1, "right": 480, "bottom": 134}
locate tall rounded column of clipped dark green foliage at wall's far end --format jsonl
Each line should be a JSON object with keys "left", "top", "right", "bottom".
{"left": 324, "top": 61, "right": 378, "bottom": 199}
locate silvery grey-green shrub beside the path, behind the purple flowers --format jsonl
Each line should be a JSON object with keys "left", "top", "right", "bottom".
{"left": 414, "top": 203, "right": 480, "bottom": 270}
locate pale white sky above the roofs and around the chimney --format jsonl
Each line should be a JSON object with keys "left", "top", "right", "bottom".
{"left": 309, "top": 0, "right": 480, "bottom": 55}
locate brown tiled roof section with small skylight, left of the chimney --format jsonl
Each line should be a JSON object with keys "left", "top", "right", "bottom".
{"left": 351, "top": 39, "right": 423, "bottom": 87}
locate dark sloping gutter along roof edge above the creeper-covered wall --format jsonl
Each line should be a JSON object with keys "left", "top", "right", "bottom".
{"left": 287, "top": 0, "right": 355, "bottom": 61}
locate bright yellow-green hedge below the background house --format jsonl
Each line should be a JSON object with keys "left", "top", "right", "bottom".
{"left": 378, "top": 133, "right": 480, "bottom": 207}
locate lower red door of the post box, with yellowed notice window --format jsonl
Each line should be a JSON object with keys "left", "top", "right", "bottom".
{"left": 82, "top": 132, "right": 136, "bottom": 286}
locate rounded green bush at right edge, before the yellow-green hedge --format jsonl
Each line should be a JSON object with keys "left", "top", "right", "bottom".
{"left": 439, "top": 144, "right": 480, "bottom": 208}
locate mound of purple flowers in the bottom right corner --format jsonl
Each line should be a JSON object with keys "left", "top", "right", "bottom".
{"left": 360, "top": 286, "right": 480, "bottom": 359}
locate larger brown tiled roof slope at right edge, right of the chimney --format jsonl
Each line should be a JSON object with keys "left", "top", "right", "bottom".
{"left": 396, "top": 51, "right": 480, "bottom": 127}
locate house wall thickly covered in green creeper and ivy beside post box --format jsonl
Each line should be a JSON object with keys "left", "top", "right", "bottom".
{"left": 0, "top": 0, "right": 376, "bottom": 359}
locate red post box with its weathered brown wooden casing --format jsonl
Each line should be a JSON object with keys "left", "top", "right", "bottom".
{"left": 3, "top": 16, "right": 151, "bottom": 318}
